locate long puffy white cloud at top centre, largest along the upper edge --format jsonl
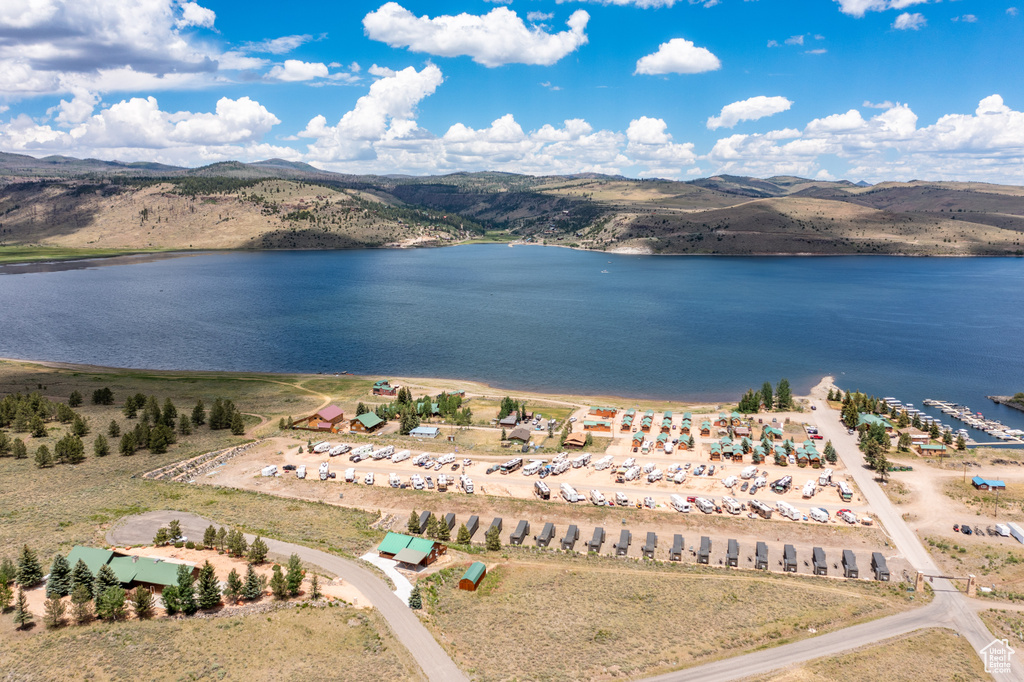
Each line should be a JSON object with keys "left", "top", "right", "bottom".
{"left": 362, "top": 2, "right": 590, "bottom": 68}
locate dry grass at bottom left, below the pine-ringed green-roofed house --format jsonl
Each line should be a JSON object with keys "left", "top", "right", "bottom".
{"left": 0, "top": 606, "right": 422, "bottom": 681}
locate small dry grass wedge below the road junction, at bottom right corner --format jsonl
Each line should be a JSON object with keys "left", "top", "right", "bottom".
{"left": 751, "top": 629, "right": 991, "bottom": 682}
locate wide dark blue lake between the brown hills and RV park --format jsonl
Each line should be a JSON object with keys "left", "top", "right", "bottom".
{"left": 0, "top": 246, "right": 1024, "bottom": 428}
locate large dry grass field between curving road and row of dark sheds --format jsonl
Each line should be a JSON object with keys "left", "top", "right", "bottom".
{"left": 420, "top": 552, "right": 920, "bottom": 682}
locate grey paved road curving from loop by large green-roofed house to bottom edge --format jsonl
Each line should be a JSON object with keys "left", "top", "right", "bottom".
{"left": 106, "top": 511, "right": 467, "bottom": 682}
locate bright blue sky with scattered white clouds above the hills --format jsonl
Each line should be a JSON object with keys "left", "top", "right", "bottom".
{"left": 0, "top": 0, "right": 1024, "bottom": 184}
